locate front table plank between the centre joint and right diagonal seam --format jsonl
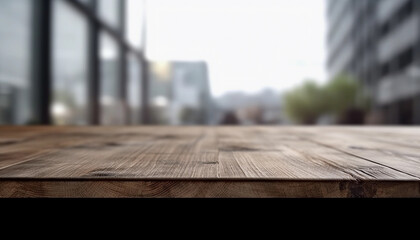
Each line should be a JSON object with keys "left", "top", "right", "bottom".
{"left": 219, "top": 127, "right": 418, "bottom": 180}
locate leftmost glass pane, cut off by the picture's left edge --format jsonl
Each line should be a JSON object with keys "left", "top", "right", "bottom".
{"left": 0, "top": 0, "right": 32, "bottom": 124}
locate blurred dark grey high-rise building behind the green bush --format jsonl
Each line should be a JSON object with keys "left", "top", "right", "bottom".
{"left": 327, "top": 0, "right": 420, "bottom": 124}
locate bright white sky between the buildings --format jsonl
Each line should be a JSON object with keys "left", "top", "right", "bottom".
{"left": 139, "top": 0, "right": 326, "bottom": 97}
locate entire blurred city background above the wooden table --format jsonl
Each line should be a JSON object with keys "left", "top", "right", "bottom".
{"left": 0, "top": 0, "right": 420, "bottom": 125}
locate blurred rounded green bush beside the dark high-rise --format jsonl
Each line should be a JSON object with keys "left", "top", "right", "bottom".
{"left": 285, "top": 75, "right": 369, "bottom": 124}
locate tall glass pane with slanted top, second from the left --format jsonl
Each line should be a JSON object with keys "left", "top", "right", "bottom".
{"left": 51, "top": 0, "right": 88, "bottom": 125}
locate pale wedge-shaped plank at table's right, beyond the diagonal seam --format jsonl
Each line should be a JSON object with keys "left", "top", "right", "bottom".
{"left": 295, "top": 128, "right": 420, "bottom": 178}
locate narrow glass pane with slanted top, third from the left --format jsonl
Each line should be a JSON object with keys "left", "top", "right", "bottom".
{"left": 100, "top": 32, "right": 125, "bottom": 125}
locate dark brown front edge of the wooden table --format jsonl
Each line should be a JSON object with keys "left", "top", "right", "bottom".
{"left": 0, "top": 179, "right": 420, "bottom": 198}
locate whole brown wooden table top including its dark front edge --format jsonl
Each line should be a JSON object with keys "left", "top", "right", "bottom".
{"left": 0, "top": 126, "right": 420, "bottom": 197}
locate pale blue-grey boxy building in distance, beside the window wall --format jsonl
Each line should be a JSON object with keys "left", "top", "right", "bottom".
{"left": 149, "top": 61, "right": 214, "bottom": 125}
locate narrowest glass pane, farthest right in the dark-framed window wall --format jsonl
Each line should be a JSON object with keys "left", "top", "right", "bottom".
{"left": 127, "top": 54, "right": 141, "bottom": 125}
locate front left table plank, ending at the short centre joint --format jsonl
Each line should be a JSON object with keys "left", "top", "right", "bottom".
{"left": 0, "top": 141, "right": 218, "bottom": 178}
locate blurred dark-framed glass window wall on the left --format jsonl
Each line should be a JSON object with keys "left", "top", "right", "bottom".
{"left": 0, "top": 0, "right": 145, "bottom": 125}
